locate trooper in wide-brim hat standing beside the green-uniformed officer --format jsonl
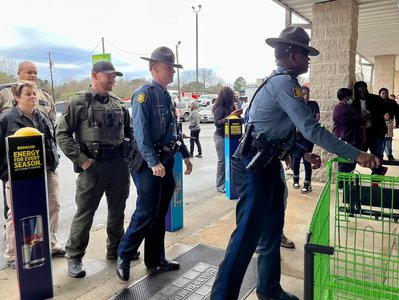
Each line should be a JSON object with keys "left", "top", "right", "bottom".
{"left": 116, "top": 47, "right": 192, "bottom": 281}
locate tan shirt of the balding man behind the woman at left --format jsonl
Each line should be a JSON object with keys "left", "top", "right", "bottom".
{"left": 0, "top": 87, "right": 56, "bottom": 122}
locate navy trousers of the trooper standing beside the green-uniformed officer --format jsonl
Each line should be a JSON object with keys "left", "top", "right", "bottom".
{"left": 118, "top": 159, "right": 175, "bottom": 267}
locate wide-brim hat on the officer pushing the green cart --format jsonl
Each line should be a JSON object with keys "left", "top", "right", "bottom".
{"left": 266, "top": 26, "right": 320, "bottom": 56}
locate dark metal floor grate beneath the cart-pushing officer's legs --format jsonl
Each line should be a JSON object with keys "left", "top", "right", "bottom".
{"left": 113, "top": 244, "right": 258, "bottom": 300}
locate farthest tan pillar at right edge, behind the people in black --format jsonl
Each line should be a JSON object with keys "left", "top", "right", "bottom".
{"left": 373, "top": 55, "right": 396, "bottom": 94}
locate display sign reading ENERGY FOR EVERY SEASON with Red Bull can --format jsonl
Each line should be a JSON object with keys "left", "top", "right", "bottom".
{"left": 6, "top": 128, "right": 53, "bottom": 299}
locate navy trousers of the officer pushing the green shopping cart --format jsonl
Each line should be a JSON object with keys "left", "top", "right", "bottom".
{"left": 211, "top": 153, "right": 285, "bottom": 299}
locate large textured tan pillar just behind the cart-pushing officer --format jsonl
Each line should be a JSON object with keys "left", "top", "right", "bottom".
{"left": 310, "top": 0, "right": 359, "bottom": 181}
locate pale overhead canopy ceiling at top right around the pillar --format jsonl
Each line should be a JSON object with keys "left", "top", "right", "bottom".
{"left": 273, "top": 0, "right": 399, "bottom": 70}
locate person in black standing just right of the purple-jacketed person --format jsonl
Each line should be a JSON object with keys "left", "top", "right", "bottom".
{"left": 352, "top": 81, "right": 388, "bottom": 175}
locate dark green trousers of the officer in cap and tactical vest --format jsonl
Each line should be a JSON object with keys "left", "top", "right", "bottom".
{"left": 65, "top": 158, "right": 130, "bottom": 259}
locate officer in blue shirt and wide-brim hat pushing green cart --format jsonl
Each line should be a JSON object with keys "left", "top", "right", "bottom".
{"left": 211, "top": 26, "right": 380, "bottom": 299}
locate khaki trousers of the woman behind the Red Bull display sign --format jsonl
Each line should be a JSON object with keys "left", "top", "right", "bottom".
{"left": 4, "top": 170, "right": 61, "bottom": 261}
